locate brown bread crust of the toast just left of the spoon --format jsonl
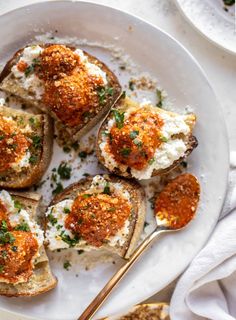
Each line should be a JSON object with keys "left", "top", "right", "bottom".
{"left": 50, "top": 175, "right": 146, "bottom": 259}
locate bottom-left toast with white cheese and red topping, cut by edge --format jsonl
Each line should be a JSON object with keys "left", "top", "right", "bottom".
{"left": 0, "top": 190, "right": 57, "bottom": 297}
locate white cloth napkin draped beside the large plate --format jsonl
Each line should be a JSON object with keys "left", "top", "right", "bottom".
{"left": 170, "top": 152, "right": 236, "bottom": 320}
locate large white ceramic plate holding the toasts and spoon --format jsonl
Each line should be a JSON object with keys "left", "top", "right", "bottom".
{"left": 0, "top": 1, "right": 228, "bottom": 320}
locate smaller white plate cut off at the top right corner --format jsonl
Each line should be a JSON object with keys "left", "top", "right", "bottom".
{"left": 176, "top": 0, "right": 236, "bottom": 54}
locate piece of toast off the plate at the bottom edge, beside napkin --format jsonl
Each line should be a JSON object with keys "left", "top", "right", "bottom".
{"left": 100, "top": 303, "right": 170, "bottom": 320}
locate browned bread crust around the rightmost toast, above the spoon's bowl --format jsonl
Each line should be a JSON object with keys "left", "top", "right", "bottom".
{"left": 96, "top": 98, "right": 198, "bottom": 179}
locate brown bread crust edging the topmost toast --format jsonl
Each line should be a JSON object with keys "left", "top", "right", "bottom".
{"left": 0, "top": 43, "right": 121, "bottom": 140}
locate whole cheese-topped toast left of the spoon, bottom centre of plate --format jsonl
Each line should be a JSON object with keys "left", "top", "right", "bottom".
{"left": 46, "top": 175, "right": 146, "bottom": 258}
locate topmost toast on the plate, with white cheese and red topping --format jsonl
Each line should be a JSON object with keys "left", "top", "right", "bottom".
{"left": 0, "top": 44, "right": 121, "bottom": 140}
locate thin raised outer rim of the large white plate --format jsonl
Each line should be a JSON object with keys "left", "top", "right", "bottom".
{"left": 0, "top": 0, "right": 230, "bottom": 320}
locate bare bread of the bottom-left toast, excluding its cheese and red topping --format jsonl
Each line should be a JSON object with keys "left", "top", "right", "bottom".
{"left": 0, "top": 192, "right": 57, "bottom": 297}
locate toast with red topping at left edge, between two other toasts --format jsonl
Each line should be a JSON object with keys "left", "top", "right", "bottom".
{"left": 0, "top": 106, "right": 53, "bottom": 189}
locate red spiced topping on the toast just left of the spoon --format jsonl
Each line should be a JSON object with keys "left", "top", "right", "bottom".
{"left": 65, "top": 194, "right": 131, "bottom": 247}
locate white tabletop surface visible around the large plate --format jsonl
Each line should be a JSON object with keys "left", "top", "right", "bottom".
{"left": 0, "top": 0, "right": 236, "bottom": 320}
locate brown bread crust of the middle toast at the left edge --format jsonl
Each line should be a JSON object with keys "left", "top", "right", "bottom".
{"left": 0, "top": 106, "right": 53, "bottom": 189}
